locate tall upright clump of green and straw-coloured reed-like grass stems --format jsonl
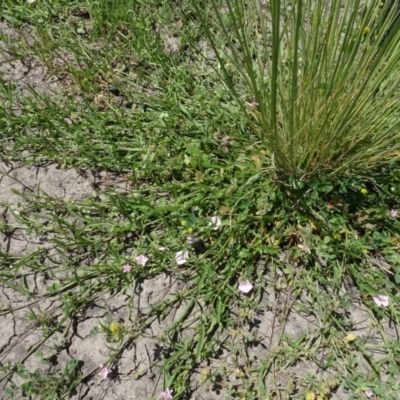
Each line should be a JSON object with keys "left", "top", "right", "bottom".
{"left": 194, "top": 0, "right": 400, "bottom": 180}
